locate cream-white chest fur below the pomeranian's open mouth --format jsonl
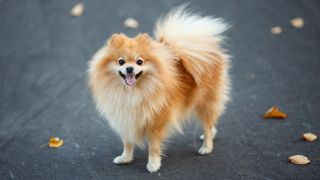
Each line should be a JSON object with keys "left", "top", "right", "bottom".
{"left": 96, "top": 83, "right": 165, "bottom": 144}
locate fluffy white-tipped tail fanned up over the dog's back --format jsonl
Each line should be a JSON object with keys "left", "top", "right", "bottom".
{"left": 154, "top": 5, "right": 229, "bottom": 83}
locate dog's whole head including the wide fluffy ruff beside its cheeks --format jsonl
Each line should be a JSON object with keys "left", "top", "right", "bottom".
{"left": 90, "top": 33, "right": 174, "bottom": 87}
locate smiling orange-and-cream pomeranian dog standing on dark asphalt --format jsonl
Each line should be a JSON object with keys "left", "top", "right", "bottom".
{"left": 88, "top": 5, "right": 230, "bottom": 172}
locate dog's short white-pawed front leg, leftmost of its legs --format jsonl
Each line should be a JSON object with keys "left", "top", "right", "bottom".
{"left": 113, "top": 139, "right": 134, "bottom": 164}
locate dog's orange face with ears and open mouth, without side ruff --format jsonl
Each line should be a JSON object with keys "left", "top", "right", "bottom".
{"left": 108, "top": 34, "right": 153, "bottom": 86}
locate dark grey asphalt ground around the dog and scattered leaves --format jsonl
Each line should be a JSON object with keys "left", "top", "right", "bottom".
{"left": 0, "top": 0, "right": 320, "bottom": 180}
